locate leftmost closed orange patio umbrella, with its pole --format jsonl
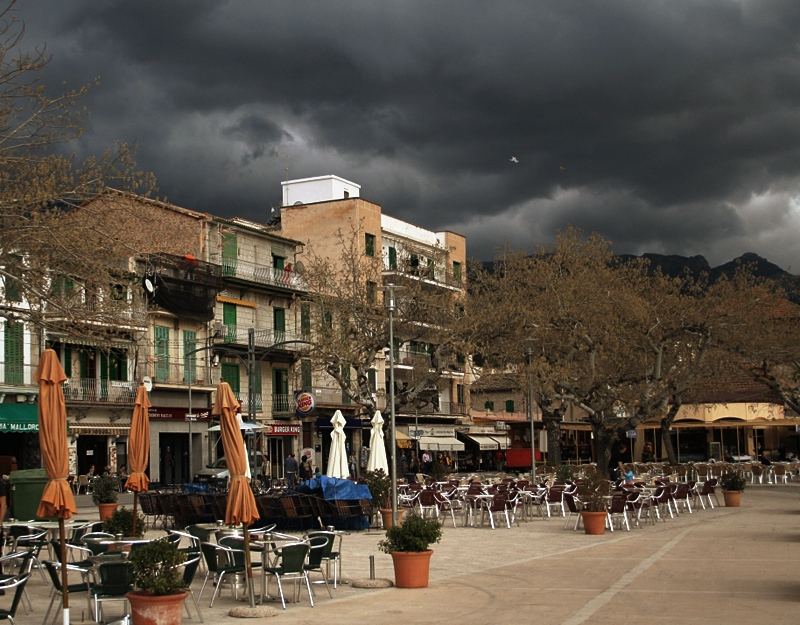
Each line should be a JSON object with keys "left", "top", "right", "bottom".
{"left": 36, "top": 349, "right": 77, "bottom": 625}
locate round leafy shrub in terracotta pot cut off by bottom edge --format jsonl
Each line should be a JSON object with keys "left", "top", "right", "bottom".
{"left": 127, "top": 540, "right": 189, "bottom": 625}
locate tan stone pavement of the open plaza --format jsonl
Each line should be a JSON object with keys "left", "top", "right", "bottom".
{"left": 7, "top": 484, "right": 800, "bottom": 625}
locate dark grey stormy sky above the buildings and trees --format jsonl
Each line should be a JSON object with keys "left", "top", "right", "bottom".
{"left": 17, "top": 0, "right": 800, "bottom": 273}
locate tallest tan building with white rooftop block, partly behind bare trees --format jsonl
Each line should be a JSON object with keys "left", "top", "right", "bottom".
{"left": 272, "top": 176, "right": 469, "bottom": 472}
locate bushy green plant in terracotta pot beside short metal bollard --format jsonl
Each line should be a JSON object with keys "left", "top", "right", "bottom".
{"left": 378, "top": 514, "right": 442, "bottom": 588}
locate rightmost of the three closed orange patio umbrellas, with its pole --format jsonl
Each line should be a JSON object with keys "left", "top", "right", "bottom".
{"left": 213, "top": 382, "right": 259, "bottom": 607}
